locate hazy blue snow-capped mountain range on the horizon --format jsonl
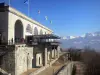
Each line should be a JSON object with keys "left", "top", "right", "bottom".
{"left": 61, "top": 31, "right": 100, "bottom": 49}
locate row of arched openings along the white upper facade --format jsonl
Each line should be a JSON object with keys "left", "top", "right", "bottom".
{"left": 14, "top": 20, "right": 46, "bottom": 40}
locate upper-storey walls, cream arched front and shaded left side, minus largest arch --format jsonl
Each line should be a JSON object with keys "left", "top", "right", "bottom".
{"left": 0, "top": 7, "right": 53, "bottom": 42}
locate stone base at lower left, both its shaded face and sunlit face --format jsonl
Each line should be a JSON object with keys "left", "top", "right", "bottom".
{"left": 0, "top": 44, "right": 33, "bottom": 75}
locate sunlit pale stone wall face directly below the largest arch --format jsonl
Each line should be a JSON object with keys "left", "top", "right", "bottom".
{"left": 15, "top": 45, "right": 33, "bottom": 75}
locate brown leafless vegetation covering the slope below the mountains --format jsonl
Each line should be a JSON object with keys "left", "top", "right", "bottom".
{"left": 68, "top": 47, "right": 100, "bottom": 75}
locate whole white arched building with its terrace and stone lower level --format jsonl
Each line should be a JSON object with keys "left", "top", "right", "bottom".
{"left": 0, "top": 3, "right": 60, "bottom": 75}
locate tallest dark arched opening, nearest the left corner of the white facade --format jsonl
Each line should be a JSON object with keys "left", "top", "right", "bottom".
{"left": 15, "top": 20, "right": 23, "bottom": 43}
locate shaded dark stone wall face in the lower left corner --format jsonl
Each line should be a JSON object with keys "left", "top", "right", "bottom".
{"left": 0, "top": 46, "right": 15, "bottom": 75}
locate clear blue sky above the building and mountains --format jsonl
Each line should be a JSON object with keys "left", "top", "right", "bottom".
{"left": 0, "top": 0, "right": 100, "bottom": 36}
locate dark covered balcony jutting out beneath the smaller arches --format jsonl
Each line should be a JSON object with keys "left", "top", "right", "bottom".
{"left": 26, "top": 34, "right": 60, "bottom": 45}
